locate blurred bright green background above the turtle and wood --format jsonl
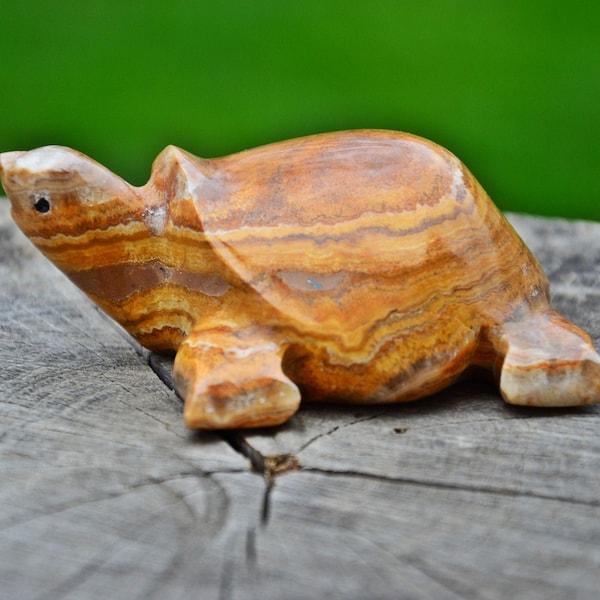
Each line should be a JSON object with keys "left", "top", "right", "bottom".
{"left": 0, "top": 0, "right": 600, "bottom": 220}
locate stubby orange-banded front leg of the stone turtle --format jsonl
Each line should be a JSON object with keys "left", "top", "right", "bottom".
{"left": 174, "top": 327, "right": 300, "bottom": 429}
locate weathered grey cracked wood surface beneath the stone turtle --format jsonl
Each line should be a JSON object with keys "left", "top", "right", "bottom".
{"left": 0, "top": 202, "right": 600, "bottom": 600}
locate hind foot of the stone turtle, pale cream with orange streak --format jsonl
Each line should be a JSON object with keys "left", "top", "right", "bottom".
{"left": 492, "top": 309, "right": 600, "bottom": 407}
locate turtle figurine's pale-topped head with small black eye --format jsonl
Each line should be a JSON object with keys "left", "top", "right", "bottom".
{"left": 0, "top": 146, "right": 133, "bottom": 245}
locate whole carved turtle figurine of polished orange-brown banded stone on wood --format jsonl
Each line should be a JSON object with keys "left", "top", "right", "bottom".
{"left": 0, "top": 130, "right": 600, "bottom": 429}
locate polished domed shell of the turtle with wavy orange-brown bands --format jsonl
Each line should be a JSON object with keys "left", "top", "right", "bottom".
{"left": 189, "top": 130, "right": 547, "bottom": 354}
